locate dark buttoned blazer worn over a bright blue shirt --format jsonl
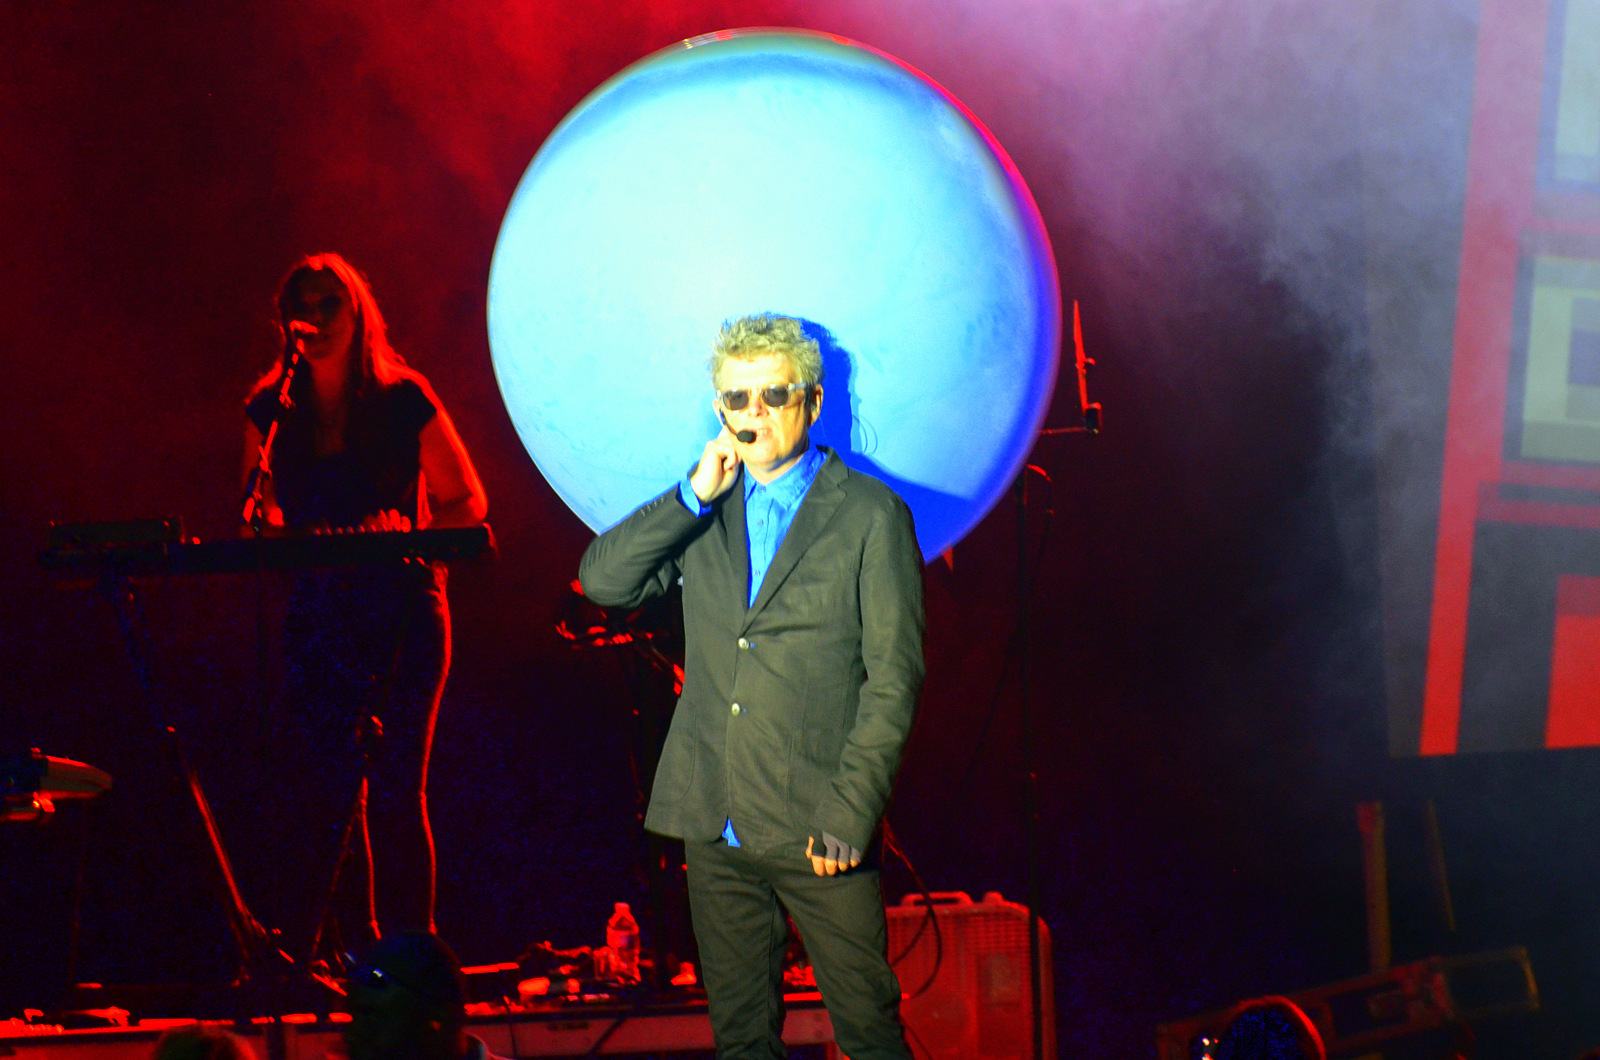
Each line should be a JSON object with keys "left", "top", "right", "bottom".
{"left": 579, "top": 450, "right": 923, "bottom": 853}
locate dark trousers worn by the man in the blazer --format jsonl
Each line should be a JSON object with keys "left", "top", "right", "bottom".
{"left": 683, "top": 839, "right": 910, "bottom": 1060}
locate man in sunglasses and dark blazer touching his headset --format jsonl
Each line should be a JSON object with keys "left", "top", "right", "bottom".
{"left": 579, "top": 315, "right": 923, "bottom": 1060}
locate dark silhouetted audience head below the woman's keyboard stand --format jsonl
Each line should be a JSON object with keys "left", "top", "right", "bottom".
{"left": 344, "top": 932, "right": 482, "bottom": 1060}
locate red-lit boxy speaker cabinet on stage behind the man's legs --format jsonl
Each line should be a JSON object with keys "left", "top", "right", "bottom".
{"left": 888, "top": 890, "right": 1056, "bottom": 1060}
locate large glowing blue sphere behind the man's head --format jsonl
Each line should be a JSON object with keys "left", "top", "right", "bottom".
{"left": 488, "top": 30, "right": 1061, "bottom": 557}
